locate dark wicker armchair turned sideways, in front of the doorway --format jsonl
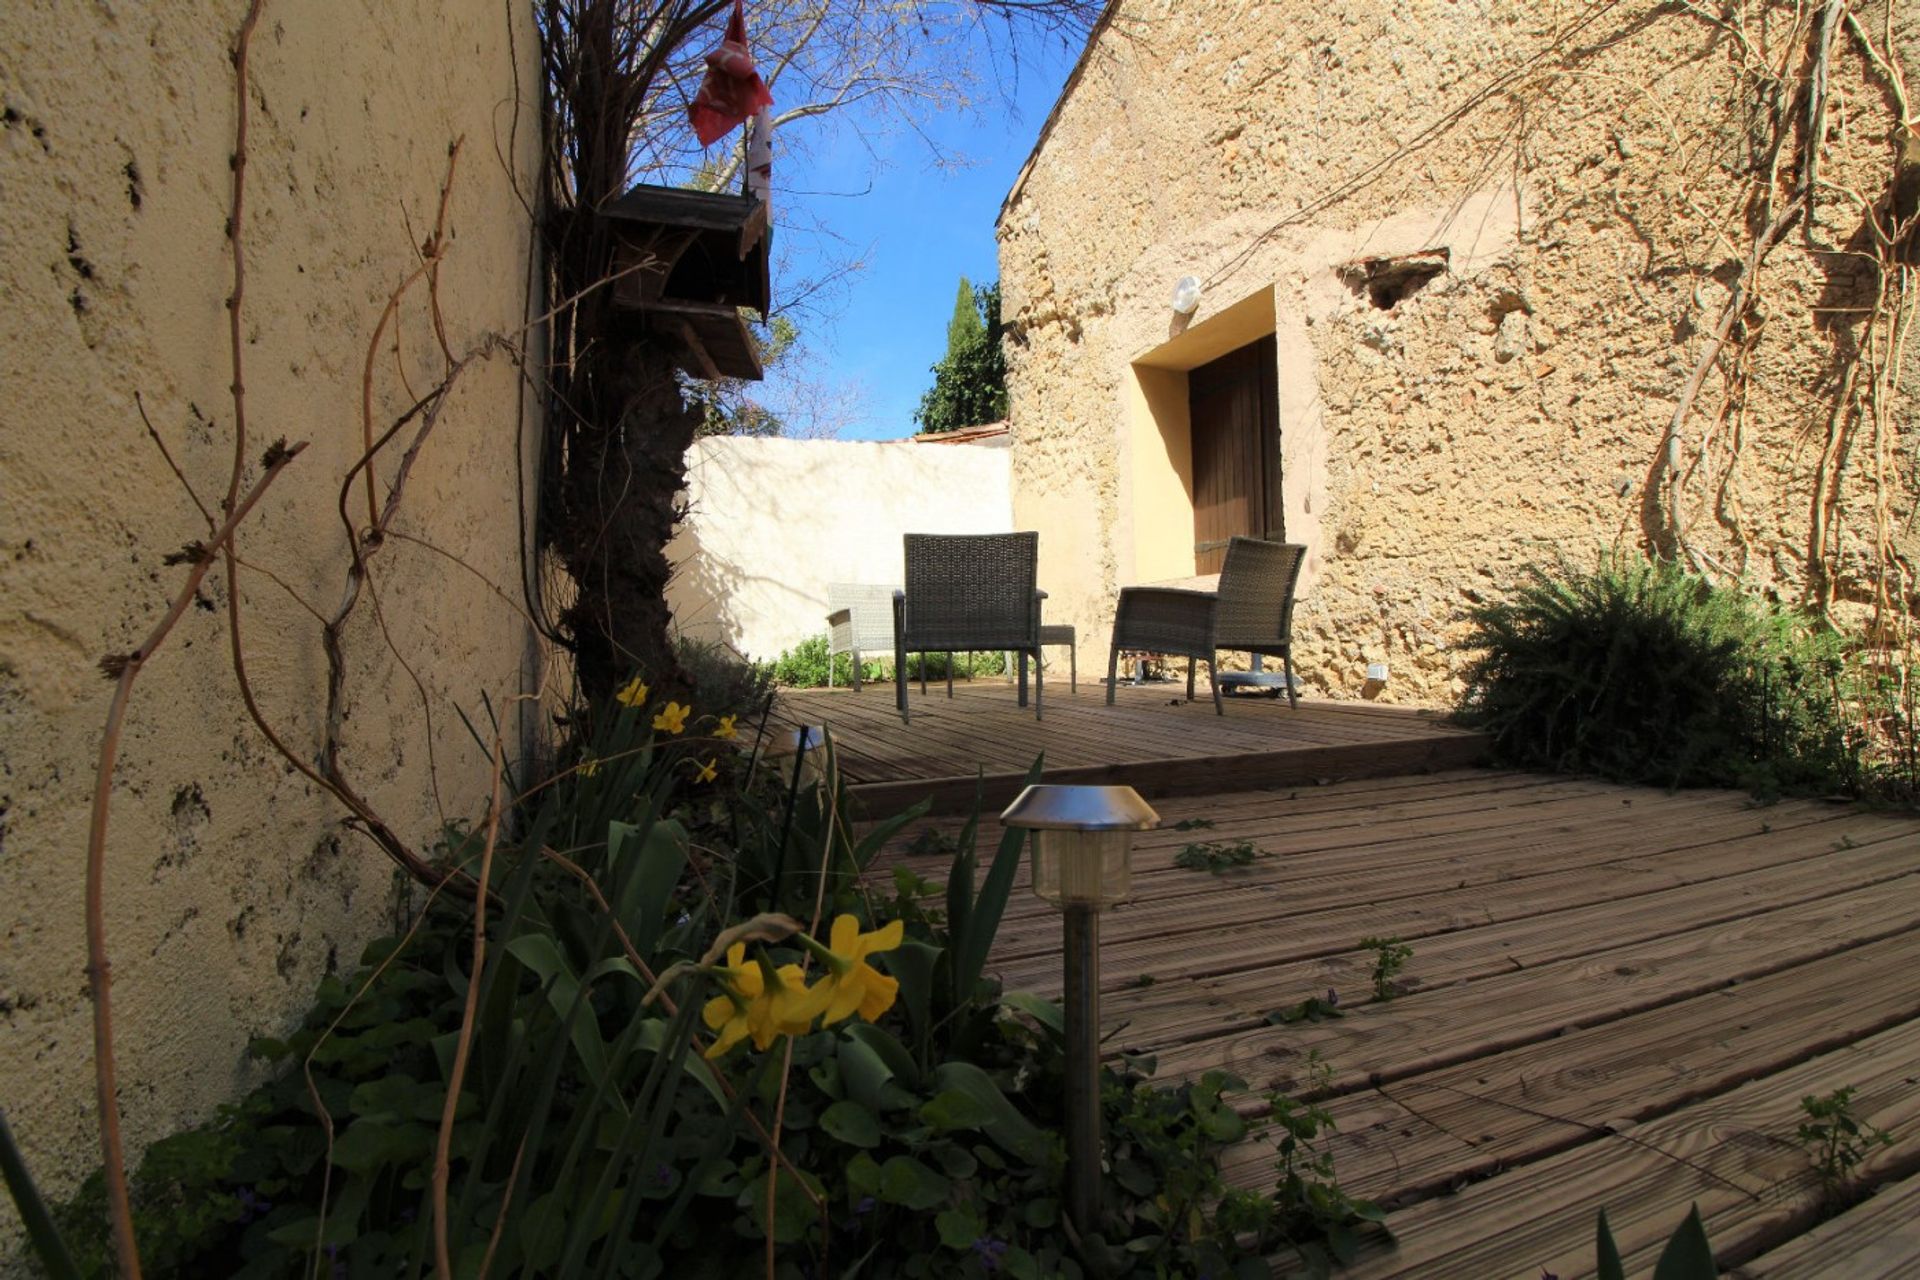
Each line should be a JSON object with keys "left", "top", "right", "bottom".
{"left": 1106, "top": 537, "right": 1306, "bottom": 716}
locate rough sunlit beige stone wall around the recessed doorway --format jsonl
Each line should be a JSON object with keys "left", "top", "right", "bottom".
{"left": 998, "top": 0, "right": 1920, "bottom": 704}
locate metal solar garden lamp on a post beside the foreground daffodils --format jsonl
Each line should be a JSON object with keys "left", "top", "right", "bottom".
{"left": 1000, "top": 785, "right": 1160, "bottom": 1234}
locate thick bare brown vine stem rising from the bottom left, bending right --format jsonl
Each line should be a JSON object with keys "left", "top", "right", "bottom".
{"left": 86, "top": 441, "right": 307, "bottom": 1276}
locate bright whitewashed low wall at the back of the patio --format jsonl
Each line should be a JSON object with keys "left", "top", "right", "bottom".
{"left": 666, "top": 436, "right": 1014, "bottom": 658}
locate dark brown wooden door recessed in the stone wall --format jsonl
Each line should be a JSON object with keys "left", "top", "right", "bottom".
{"left": 1187, "top": 336, "right": 1286, "bottom": 574}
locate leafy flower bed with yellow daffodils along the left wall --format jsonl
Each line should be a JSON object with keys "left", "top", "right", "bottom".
{"left": 45, "top": 679, "right": 1373, "bottom": 1280}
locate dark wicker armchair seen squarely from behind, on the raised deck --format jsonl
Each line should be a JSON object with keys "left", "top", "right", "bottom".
{"left": 893, "top": 533, "right": 1041, "bottom": 722}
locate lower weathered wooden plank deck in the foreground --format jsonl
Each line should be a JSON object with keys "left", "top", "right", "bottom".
{"left": 867, "top": 771, "right": 1920, "bottom": 1280}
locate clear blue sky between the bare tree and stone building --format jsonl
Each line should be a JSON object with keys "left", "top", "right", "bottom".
{"left": 764, "top": 21, "right": 1079, "bottom": 439}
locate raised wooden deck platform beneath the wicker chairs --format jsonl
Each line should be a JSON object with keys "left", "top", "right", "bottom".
{"left": 774, "top": 677, "right": 1486, "bottom": 814}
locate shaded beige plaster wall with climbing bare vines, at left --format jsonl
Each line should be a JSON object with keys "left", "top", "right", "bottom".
{"left": 0, "top": 0, "right": 538, "bottom": 1228}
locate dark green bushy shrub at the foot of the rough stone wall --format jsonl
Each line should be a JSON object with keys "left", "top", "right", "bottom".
{"left": 1459, "top": 557, "right": 1860, "bottom": 793}
